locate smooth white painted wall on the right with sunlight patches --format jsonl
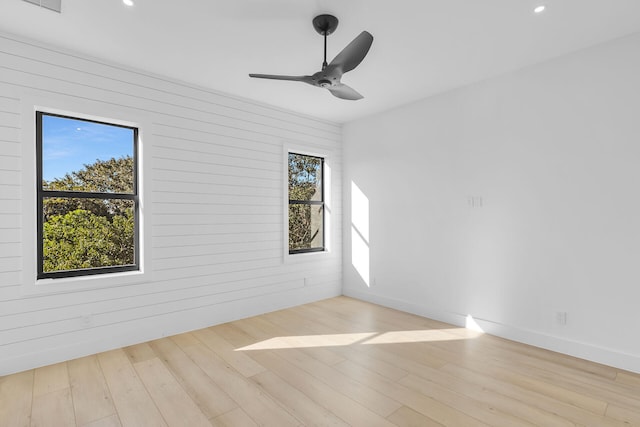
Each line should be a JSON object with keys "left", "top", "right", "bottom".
{"left": 343, "top": 34, "right": 640, "bottom": 372}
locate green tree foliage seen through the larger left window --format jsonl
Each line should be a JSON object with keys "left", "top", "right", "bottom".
{"left": 43, "top": 157, "right": 135, "bottom": 272}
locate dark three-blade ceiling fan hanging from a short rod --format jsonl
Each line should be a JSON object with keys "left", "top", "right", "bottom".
{"left": 249, "top": 15, "right": 373, "bottom": 101}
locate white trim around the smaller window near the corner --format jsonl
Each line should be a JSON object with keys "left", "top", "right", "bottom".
{"left": 282, "top": 142, "right": 333, "bottom": 263}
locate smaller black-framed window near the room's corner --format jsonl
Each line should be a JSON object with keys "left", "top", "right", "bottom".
{"left": 288, "top": 153, "right": 325, "bottom": 254}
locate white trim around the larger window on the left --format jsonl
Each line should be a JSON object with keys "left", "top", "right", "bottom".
{"left": 21, "top": 92, "right": 152, "bottom": 295}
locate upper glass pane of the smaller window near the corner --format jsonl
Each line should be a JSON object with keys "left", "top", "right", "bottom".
{"left": 289, "top": 153, "right": 322, "bottom": 201}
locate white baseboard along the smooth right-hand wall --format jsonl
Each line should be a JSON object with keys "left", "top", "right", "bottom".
{"left": 343, "top": 288, "right": 640, "bottom": 373}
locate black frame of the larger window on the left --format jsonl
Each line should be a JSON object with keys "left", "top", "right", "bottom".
{"left": 35, "top": 109, "right": 141, "bottom": 280}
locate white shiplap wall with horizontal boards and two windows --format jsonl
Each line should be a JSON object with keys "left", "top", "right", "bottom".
{"left": 0, "top": 33, "right": 342, "bottom": 375}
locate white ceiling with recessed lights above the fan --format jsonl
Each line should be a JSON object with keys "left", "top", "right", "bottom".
{"left": 0, "top": 0, "right": 640, "bottom": 123}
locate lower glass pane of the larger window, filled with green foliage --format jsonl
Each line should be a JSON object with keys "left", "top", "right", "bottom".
{"left": 43, "top": 198, "right": 135, "bottom": 273}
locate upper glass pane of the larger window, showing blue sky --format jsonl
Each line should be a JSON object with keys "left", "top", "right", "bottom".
{"left": 42, "top": 114, "right": 135, "bottom": 193}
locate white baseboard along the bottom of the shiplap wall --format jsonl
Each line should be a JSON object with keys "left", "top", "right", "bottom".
{"left": 0, "top": 285, "right": 342, "bottom": 376}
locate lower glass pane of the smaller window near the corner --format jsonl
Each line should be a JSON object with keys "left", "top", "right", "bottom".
{"left": 289, "top": 204, "right": 324, "bottom": 251}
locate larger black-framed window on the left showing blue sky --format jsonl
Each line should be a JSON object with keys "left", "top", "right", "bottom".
{"left": 36, "top": 111, "right": 140, "bottom": 279}
